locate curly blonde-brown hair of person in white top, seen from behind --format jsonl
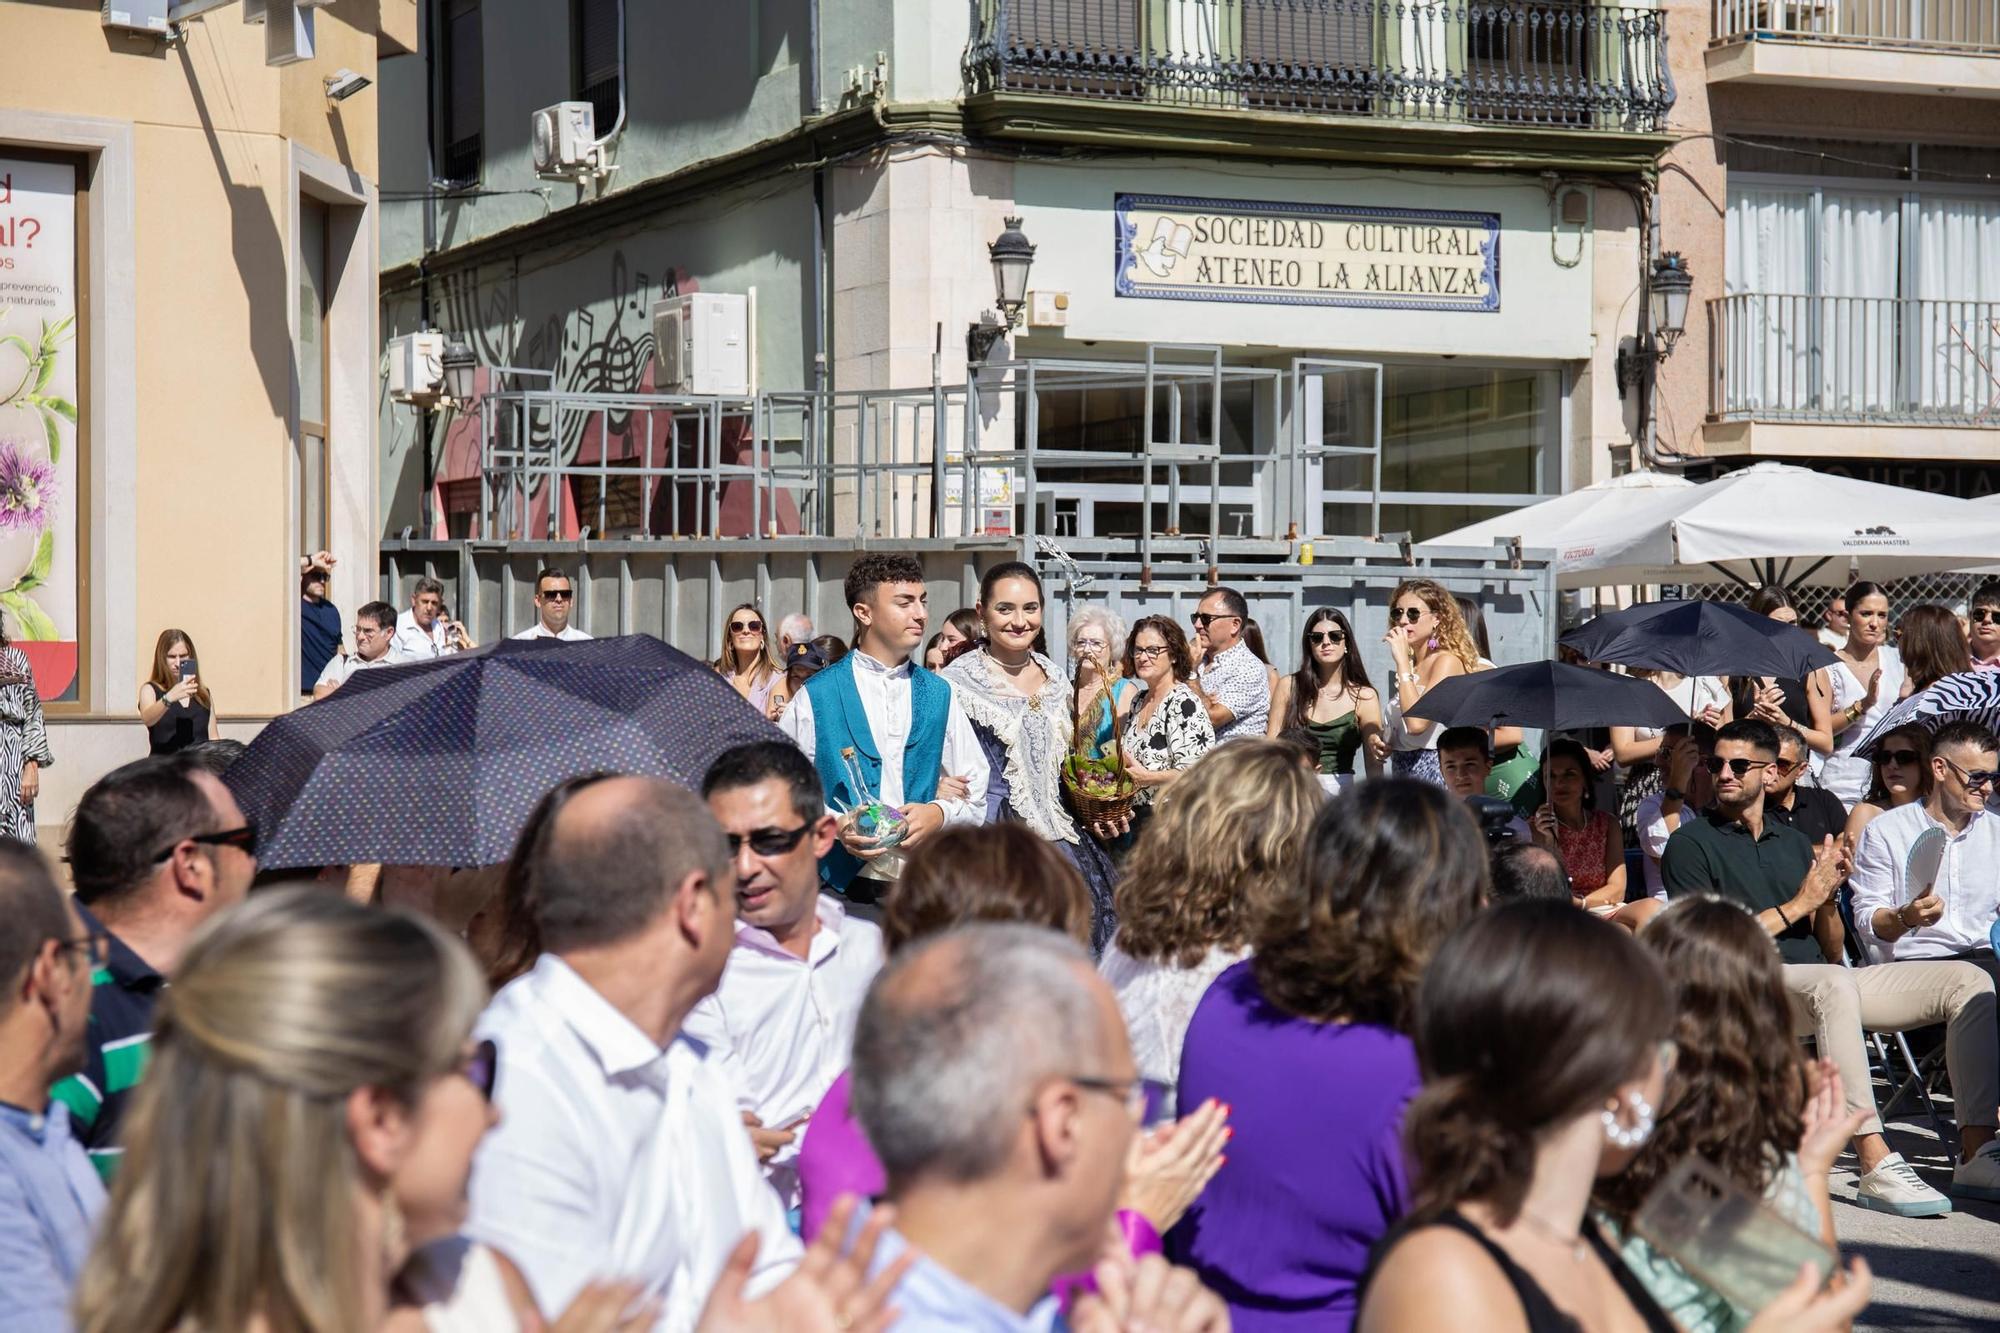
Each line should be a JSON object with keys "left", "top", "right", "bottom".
{"left": 1114, "top": 741, "right": 1320, "bottom": 967}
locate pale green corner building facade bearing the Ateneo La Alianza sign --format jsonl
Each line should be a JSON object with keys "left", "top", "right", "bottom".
{"left": 382, "top": 0, "right": 1700, "bottom": 576}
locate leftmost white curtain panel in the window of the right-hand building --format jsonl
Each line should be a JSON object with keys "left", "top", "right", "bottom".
{"left": 1722, "top": 186, "right": 1812, "bottom": 412}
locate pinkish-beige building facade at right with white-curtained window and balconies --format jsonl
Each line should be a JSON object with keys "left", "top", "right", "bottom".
{"left": 1660, "top": 0, "right": 2000, "bottom": 498}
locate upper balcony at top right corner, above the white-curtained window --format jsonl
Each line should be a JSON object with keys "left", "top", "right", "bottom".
{"left": 1708, "top": 0, "right": 2000, "bottom": 98}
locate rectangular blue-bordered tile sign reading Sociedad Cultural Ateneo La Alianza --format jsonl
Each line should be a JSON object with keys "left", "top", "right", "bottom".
{"left": 1116, "top": 194, "right": 1500, "bottom": 310}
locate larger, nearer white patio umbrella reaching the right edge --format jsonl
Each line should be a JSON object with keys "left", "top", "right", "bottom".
{"left": 1438, "top": 462, "right": 2000, "bottom": 588}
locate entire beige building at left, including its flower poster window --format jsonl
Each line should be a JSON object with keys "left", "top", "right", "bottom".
{"left": 0, "top": 0, "right": 402, "bottom": 825}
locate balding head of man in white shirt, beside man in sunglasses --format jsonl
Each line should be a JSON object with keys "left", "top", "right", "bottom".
{"left": 530, "top": 777, "right": 734, "bottom": 953}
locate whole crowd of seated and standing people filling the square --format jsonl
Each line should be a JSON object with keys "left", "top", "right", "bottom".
{"left": 11, "top": 552, "right": 2000, "bottom": 1333}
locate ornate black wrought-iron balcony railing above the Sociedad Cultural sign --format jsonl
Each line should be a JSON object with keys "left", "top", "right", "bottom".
{"left": 966, "top": 0, "right": 1674, "bottom": 132}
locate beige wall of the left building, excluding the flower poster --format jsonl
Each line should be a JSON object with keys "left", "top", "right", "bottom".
{"left": 0, "top": 0, "right": 390, "bottom": 841}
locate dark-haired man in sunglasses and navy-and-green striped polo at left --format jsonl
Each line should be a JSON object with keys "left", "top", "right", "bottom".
{"left": 54, "top": 757, "right": 256, "bottom": 1181}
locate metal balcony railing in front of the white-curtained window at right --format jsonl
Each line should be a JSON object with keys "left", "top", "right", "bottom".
{"left": 1708, "top": 294, "right": 2000, "bottom": 426}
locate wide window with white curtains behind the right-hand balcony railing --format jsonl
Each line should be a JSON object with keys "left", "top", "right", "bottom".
{"left": 1716, "top": 140, "right": 2000, "bottom": 420}
